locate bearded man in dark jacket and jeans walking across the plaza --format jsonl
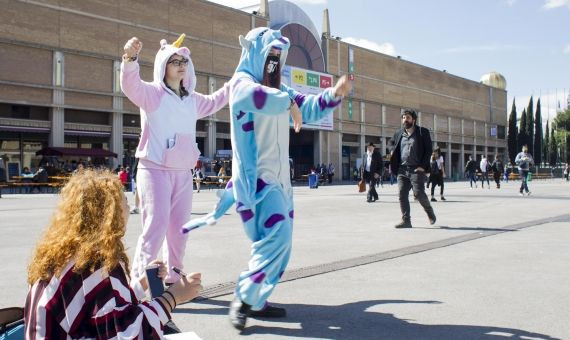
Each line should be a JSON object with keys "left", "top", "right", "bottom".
{"left": 390, "top": 109, "right": 436, "bottom": 228}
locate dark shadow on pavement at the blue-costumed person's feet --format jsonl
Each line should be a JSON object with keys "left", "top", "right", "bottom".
{"left": 177, "top": 299, "right": 556, "bottom": 340}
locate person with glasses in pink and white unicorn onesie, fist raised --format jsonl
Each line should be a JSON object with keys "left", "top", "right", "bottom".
{"left": 121, "top": 34, "right": 229, "bottom": 284}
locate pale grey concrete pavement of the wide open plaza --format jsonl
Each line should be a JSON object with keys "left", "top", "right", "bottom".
{"left": 0, "top": 180, "right": 570, "bottom": 339}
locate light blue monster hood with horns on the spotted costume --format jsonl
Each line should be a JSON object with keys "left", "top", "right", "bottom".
{"left": 236, "top": 27, "right": 290, "bottom": 82}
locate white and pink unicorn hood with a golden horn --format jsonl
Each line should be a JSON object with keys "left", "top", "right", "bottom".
{"left": 154, "top": 33, "right": 196, "bottom": 94}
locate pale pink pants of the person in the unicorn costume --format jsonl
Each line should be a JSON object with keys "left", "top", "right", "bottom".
{"left": 131, "top": 168, "right": 192, "bottom": 283}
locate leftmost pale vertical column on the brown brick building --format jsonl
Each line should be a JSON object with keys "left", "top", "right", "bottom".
{"left": 49, "top": 51, "right": 65, "bottom": 147}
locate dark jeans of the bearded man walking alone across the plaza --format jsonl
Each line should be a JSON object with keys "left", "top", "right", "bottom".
{"left": 398, "top": 168, "right": 434, "bottom": 221}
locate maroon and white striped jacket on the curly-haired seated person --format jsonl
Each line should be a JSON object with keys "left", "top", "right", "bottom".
{"left": 24, "top": 262, "right": 170, "bottom": 339}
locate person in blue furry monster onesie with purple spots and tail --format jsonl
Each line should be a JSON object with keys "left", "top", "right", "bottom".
{"left": 182, "top": 27, "right": 351, "bottom": 330}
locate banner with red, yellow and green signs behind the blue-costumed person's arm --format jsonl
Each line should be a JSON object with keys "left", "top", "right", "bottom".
{"left": 281, "top": 65, "right": 333, "bottom": 131}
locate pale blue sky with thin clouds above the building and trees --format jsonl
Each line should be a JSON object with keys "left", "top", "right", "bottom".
{"left": 206, "top": 0, "right": 570, "bottom": 123}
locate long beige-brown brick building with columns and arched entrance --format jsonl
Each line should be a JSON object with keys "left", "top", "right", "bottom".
{"left": 0, "top": 0, "right": 507, "bottom": 180}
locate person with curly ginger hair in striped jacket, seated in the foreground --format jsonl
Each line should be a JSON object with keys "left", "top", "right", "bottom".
{"left": 24, "top": 170, "right": 202, "bottom": 339}
